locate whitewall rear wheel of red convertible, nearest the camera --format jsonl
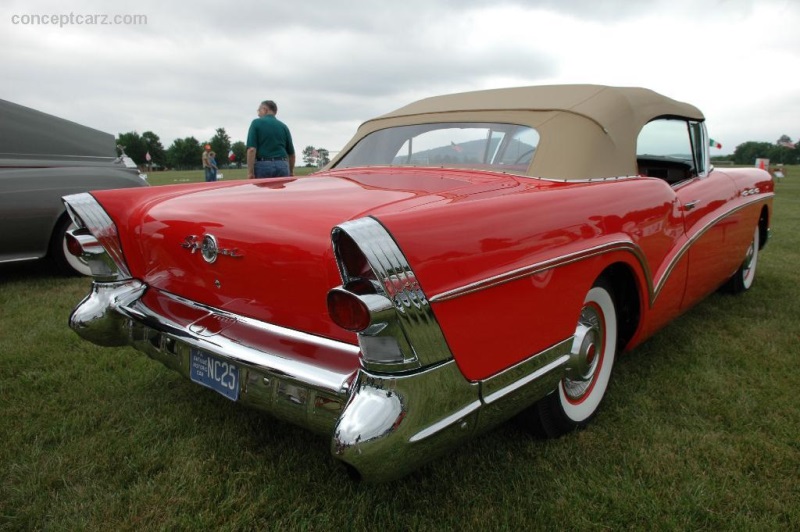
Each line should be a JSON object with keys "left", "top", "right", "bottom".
{"left": 523, "top": 282, "right": 617, "bottom": 438}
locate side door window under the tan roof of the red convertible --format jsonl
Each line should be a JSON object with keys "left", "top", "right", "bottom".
{"left": 636, "top": 118, "right": 705, "bottom": 185}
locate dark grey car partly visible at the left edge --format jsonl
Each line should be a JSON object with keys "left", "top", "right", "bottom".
{"left": 0, "top": 100, "right": 147, "bottom": 275}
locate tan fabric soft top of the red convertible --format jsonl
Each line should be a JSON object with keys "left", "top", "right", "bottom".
{"left": 332, "top": 85, "right": 704, "bottom": 179}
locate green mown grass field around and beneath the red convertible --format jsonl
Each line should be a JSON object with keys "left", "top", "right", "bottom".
{"left": 0, "top": 167, "right": 800, "bottom": 530}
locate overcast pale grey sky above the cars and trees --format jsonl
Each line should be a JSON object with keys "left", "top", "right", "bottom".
{"left": 0, "top": 0, "right": 800, "bottom": 154}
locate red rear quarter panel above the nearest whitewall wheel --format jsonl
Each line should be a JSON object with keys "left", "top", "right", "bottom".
{"left": 380, "top": 178, "right": 685, "bottom": 380}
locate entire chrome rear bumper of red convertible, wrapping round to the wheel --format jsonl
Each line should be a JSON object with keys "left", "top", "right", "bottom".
{"left": 70, "top": 280, "right": 572, "bottom": 481}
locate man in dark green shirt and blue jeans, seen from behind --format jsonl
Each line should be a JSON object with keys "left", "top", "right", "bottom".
{"left": 247, "top": 100, "right": 295, "bottom": 179}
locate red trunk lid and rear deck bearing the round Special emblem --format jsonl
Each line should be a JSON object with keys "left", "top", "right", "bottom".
{"left": 93, "top": 169, "right": 515, "bottom": 342}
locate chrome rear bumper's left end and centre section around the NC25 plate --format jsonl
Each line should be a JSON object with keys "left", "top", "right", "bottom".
{"left": 70, "top": 281, "right": 358, "bottom": 434}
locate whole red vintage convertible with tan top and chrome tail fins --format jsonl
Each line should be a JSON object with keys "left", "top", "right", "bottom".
{"left": 65, "top": 85, "right": 774, "bottom": 481}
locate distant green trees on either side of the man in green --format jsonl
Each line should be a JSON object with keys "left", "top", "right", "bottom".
{"left": 117, "top": 127, "right": 330, "bottom": 170}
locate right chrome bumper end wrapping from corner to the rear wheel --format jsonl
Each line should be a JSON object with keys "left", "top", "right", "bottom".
{"left": 331, "top": 338, "right": 572, "bottom": 481}
